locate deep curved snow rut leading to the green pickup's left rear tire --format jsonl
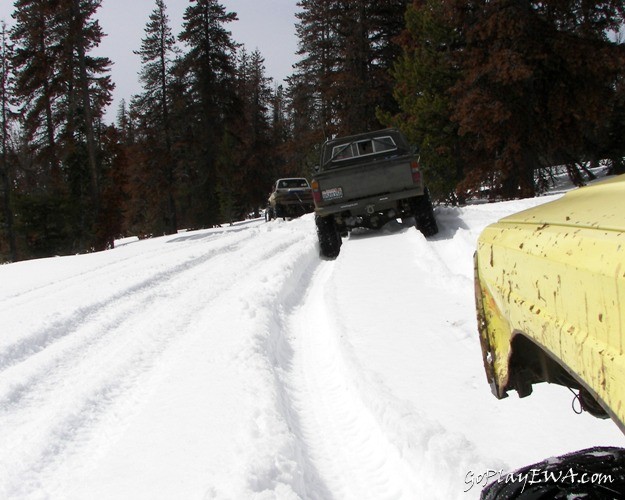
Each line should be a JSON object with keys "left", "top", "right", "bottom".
{"left": 288, "top": 262, "right": 418, "bottom": 500}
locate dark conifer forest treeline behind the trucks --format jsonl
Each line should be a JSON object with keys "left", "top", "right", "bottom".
{"left": 0, "top": 0, "right": 625, "bottom": 261}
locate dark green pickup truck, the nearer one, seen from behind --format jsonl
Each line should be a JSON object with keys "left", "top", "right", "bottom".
{"left": 311, "top": 129, "right": 438, "bottom": 258}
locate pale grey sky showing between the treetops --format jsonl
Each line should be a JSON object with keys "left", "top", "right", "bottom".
{"left": 0, "top": 0, "right": 298, "bottom": 120}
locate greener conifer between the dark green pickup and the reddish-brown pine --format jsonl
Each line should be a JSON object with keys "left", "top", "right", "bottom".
{"left": 379, "top": 0, "right": 463, "bottom": 203}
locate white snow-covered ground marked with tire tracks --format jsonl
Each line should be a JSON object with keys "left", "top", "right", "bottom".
{"left": 0, "top": 182, "right": 625, "bottom": 500}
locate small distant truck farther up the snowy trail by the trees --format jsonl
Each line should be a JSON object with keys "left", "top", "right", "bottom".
{"left": 265, "top": 177, "right": 314, "bottom": 221}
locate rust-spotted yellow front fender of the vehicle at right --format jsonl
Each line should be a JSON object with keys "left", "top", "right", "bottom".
{"left": 475, "top": 176, "right": 625, "bottom": 432}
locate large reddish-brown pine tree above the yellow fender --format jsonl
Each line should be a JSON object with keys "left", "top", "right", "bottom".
{"left": 453, "top": 0, "right": 623, "bottom": 197}
